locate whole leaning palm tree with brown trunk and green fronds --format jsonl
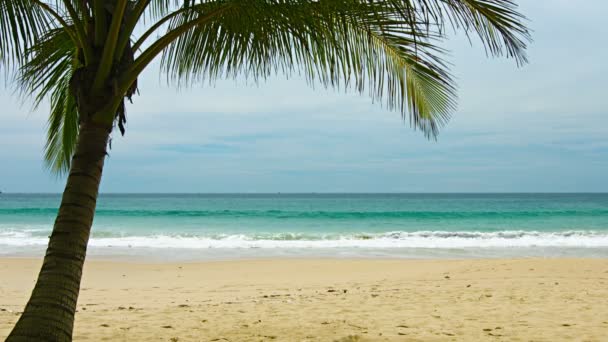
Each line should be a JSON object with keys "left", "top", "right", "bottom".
{"left": 0, "top": 0, "right": 530, "bottom": 341}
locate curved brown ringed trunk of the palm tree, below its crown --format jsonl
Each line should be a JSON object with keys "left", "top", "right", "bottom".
{"left": 7, "top": 122, "right": 111, "bottom": 342}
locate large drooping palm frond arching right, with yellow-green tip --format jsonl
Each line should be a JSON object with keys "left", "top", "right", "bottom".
{"left": 162, "top": 0, "right": 456, "bottom": 136}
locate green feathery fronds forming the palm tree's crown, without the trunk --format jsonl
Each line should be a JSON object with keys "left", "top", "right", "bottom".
{"left": 0, "top": 0, "right": 530, "bottom": 171}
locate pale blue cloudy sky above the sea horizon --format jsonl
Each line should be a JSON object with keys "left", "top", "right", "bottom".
{"left": 0, "top": 0, "right": 608, "bottom": 193}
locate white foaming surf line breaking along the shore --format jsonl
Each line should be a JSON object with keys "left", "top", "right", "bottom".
{"left": 0, "top": 230, "right": 608, "bottom": 249}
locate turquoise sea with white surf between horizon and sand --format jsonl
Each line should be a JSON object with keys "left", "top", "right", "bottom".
{"left": 0, "top": 194, "right": 608, "bottom": 261}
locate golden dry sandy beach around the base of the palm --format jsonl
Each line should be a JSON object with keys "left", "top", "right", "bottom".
{"left": 0, "top": 259, "right": 608, "bottom": 341}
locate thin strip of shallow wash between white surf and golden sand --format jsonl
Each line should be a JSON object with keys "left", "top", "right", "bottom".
{"left": 0, "top": 244, "right": 608, "bottom": 263}
